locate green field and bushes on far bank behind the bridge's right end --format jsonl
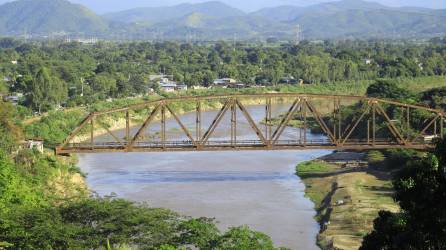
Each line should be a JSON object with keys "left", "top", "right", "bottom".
{"left": 263, "top": 77, "right": 446, "bottom": 139}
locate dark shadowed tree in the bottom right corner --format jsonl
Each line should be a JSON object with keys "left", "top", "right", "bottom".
{"left": 361, "top": 140, "right": 446, "bottom": 250}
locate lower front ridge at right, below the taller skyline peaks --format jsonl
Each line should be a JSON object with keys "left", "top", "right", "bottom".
{"left": 290, "top": 10, "right": 446, "bottom": 39}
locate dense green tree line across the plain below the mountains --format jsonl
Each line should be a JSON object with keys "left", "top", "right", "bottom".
{"left": 0, "top": 39, "right": 446, "bottom": 110}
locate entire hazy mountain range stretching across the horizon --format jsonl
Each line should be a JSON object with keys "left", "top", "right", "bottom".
{"left": 0, "top": 0, "right": 446, "bottom": 40}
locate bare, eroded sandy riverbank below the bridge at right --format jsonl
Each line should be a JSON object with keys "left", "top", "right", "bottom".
{"left": 296, "top": 153, "right": 399, "bottom": 250}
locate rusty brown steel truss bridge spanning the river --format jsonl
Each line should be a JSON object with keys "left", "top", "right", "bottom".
{"left": 56, "top": 93, "right": 445, "bottom": 154}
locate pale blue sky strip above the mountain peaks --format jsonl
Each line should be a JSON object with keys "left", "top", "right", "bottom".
{"left": 0, "top": 0, "right": 446, "bottom": 14}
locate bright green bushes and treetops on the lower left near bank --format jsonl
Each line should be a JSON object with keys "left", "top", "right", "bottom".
{"left": 0, "top": 101, "right": 286, "bottom": 249}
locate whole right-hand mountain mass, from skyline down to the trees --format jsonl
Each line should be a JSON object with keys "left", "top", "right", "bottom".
{"left": 251, "top": 0, "right": 446, "bottom": 39}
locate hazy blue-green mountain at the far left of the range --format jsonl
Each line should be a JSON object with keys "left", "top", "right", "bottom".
{"left": 0, "top": 0, "right": 108, "bottom": 35}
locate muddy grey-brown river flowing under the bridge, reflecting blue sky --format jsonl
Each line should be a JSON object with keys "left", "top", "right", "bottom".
{"left": 79, "top": 104, "right": 330, "bottom": 250}
